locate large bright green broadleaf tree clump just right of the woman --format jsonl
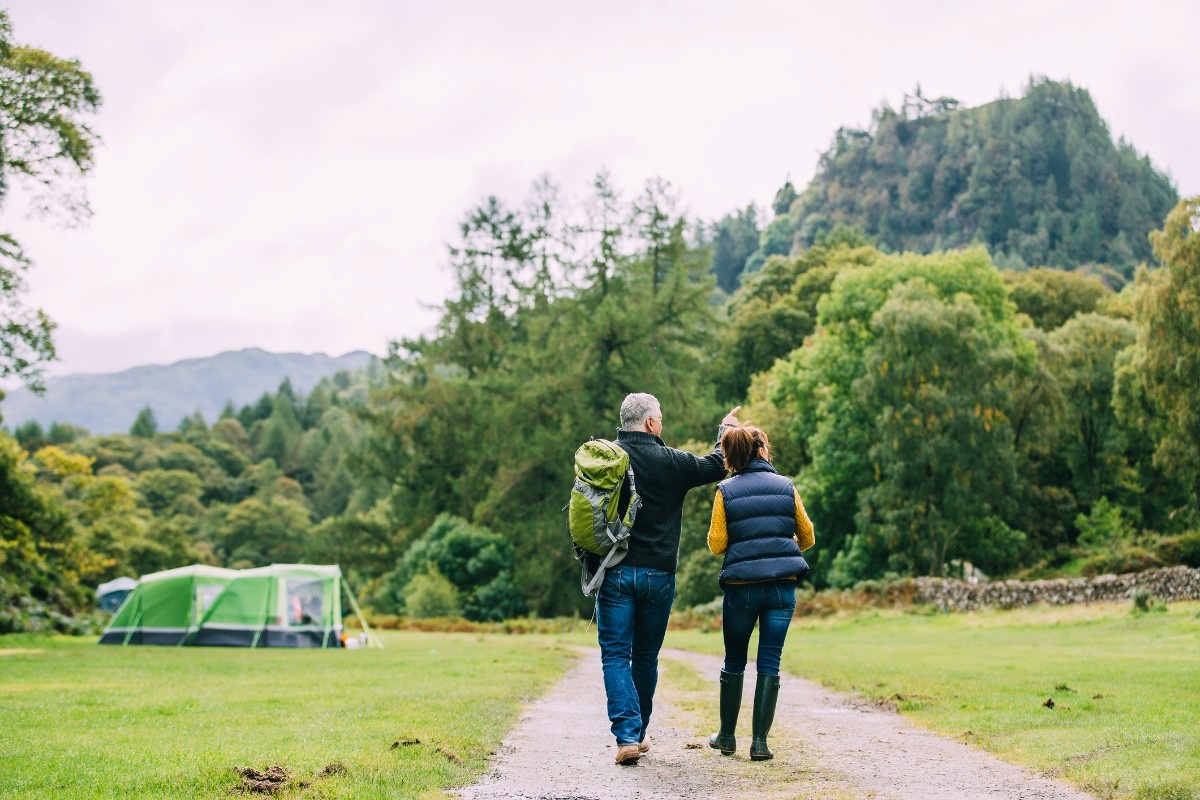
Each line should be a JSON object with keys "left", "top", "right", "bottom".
{"left": 755, "top": 249, "right": 1034, "bottom": 585}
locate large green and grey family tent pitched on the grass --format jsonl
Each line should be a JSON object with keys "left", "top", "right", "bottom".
{"left": 100, "top": 564, "right": 374, "bottom": 648}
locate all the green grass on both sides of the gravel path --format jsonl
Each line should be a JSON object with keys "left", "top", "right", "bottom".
{"left": 0, "top": 603, "right": 1200, "bottom": 800}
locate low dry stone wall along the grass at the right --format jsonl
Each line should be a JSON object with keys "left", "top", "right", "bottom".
{"left": 913, "top": 566, "right": 1200, "bottom": 610}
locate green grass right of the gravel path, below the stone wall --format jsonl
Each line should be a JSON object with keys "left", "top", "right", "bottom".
{"left": 667, "top": 602, "right": 1200, "bottom": 800}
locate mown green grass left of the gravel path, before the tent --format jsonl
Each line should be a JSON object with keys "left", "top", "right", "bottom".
{"left": 0, "top": 633, "right": 571, "bottom": 800}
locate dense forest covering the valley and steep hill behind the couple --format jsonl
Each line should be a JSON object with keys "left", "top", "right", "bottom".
{"left": 0, "top": 20, "right": 1200, "bottom": 631}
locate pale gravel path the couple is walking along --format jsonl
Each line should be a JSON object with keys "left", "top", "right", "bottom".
{"left": 457, "top": 649, "right": 1092, "bottom": 800}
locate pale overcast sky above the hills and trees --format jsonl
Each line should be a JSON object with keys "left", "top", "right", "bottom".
{"left": 0, "top": 0, "right": 1200, "bottom": 374}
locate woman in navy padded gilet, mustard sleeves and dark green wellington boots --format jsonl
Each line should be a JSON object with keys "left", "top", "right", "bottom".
{"left": 708, "top": 425, "right": 815, "bottom": 762}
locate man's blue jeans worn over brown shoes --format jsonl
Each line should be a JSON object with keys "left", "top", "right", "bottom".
{"left": 596, "top": 564, "right": 674, "bottom": 745}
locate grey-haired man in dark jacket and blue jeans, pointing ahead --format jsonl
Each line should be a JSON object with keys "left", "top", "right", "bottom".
{"left": 596, "top": 393, "right": 742, "bottom": 764}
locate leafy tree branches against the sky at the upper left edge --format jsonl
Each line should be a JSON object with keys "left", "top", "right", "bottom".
{"left": 0, "top": 10, "right": 100, "bottom": 391}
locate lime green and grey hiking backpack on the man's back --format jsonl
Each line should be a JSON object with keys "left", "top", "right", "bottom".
{"left": 566, "top": 439, "right": 642, "bottom": 597}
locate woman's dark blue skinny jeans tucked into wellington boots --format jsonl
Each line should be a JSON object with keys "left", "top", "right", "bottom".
{"left": 721, "top": 581, "right": 796, "bottom": 675}
